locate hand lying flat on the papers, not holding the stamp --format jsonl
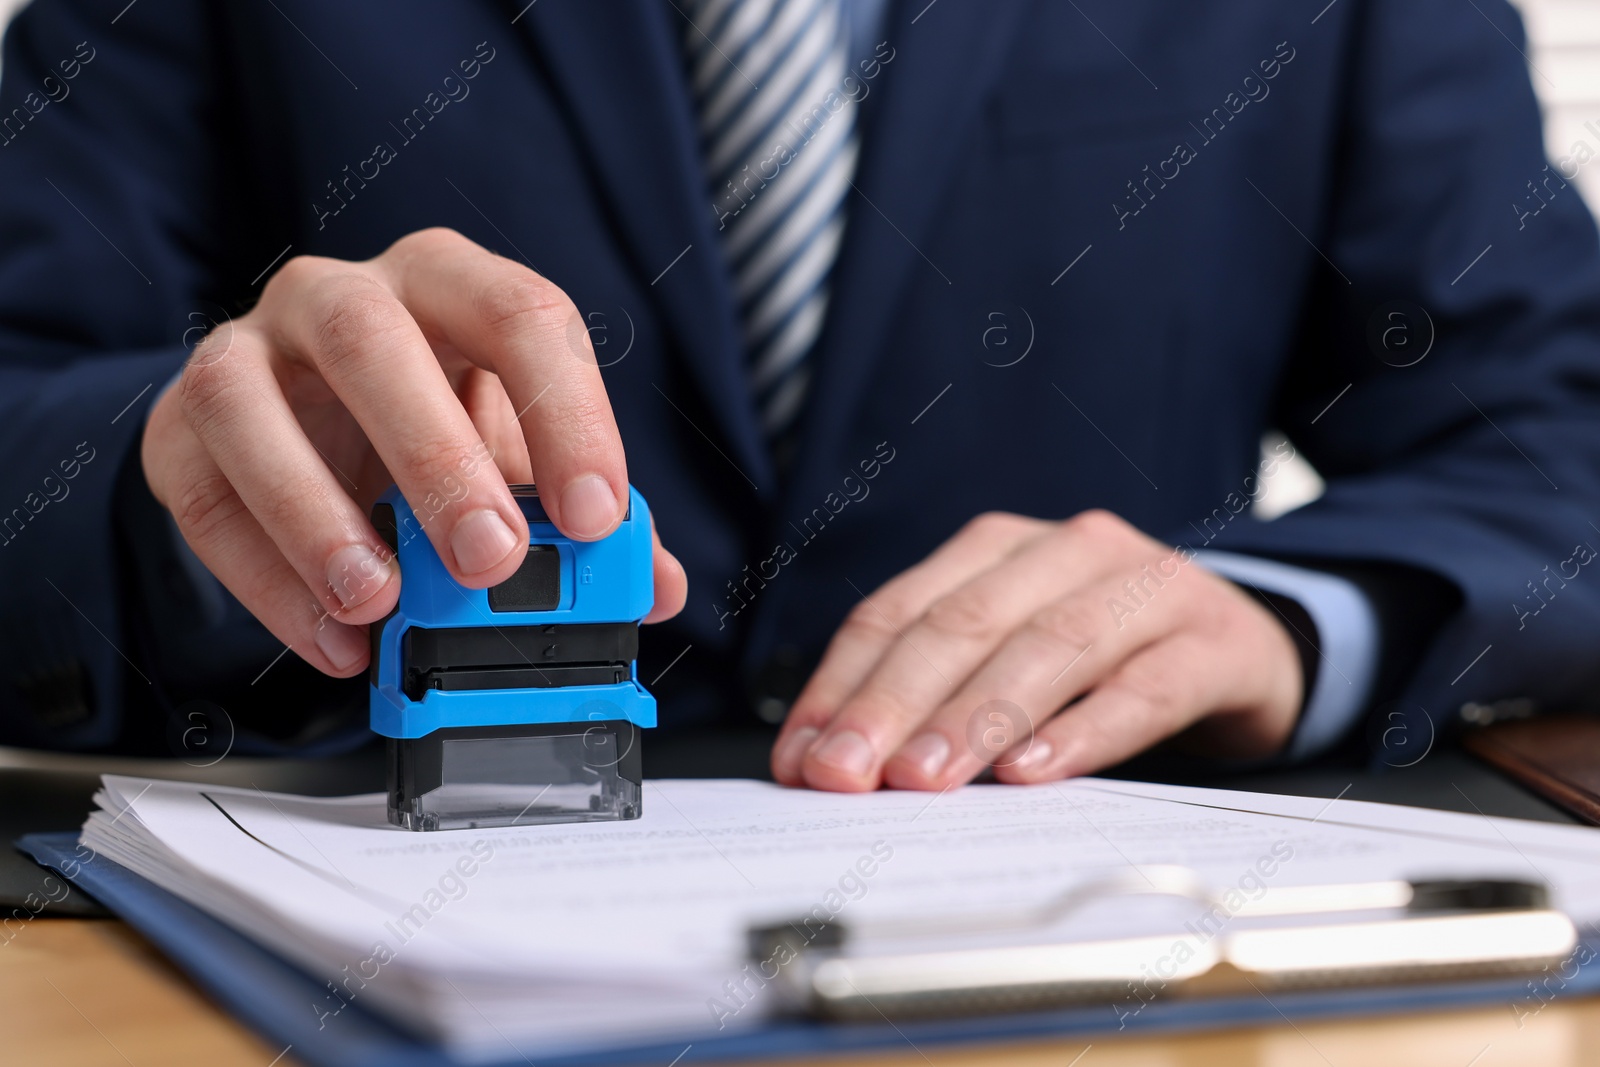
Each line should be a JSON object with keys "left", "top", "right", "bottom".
{"left": 773, "top": 512, "right": 1304, "bottom": 792}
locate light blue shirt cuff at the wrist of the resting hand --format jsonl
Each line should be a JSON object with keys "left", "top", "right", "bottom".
{"left": 1195, "top": 550, "right": 1379, "bottom": 760}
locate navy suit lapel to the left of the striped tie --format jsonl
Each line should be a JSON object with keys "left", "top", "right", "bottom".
{"left": 515, "top": 0, "right": 774, "bottom": 496}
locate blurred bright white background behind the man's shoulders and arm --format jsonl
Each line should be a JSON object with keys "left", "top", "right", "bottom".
{"left": 0, "top": 0, "right": 1600, "bottom": 518}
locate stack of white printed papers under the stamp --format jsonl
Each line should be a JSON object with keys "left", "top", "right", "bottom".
{"left": 82, "top": 776, "right": 1600, "bottom": 1059}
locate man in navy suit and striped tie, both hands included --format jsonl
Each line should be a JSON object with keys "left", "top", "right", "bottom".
{"left": 0, "top": 0, "right": 1600, "bottom": 790}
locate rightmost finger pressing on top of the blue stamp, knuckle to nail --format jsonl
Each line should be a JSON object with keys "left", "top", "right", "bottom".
{"left": 373, "top": 230, "right": 627, "bottom": 541}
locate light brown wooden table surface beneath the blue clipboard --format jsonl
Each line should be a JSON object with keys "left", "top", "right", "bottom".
{"left": 0, "top": 918, "right": 1600, "bottom": 1067}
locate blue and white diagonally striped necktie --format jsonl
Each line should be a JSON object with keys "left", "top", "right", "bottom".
{"left": 685, "top": 0, "right": 856, "bottom": 464}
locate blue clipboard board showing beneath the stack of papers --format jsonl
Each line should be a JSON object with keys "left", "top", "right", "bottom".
{"left": 16, "top": 833, "right": 1600, "bottom": 1067}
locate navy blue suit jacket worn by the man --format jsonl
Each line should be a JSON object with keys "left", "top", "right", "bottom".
{"left": 0, "top": 0, "right": 1600, "bottom": 747}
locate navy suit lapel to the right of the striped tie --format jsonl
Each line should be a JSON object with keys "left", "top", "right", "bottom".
{"left": 786, "top": 0, "right": 1026, "bottom": 512}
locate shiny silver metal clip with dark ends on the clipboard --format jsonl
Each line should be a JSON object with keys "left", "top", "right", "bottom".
{"left": 749, "top": 867, "right": 1578, "bottom": 1022}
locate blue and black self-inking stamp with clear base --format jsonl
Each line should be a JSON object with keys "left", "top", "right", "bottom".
{"left": 371, "top": 485, "right": 656, "bottom": 830}
